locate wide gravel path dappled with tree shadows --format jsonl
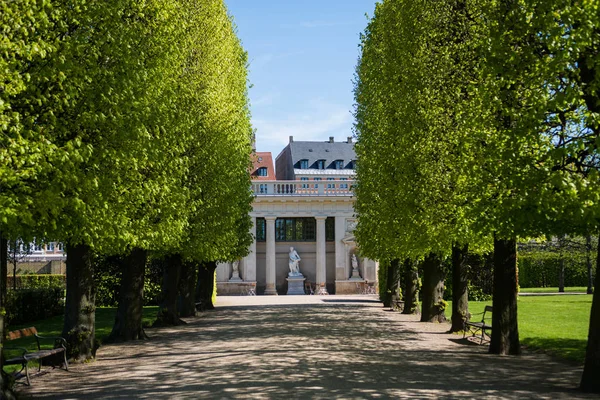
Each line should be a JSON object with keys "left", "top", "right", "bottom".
{"left": 20, "top": 296, "right": 597, "bottom": 399}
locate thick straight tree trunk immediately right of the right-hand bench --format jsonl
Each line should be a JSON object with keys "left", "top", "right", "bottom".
{"left": 490, "top": 238, "right": 521, "bottom": 355}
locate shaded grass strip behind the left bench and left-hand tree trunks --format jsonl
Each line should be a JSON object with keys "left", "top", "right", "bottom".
{"left": 4, "top": 307, "right": 158, "bottom": 372}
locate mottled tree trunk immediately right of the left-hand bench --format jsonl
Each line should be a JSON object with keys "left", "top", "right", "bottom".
{"left": 62, "top": 243, "right": 98, "bottom": 362}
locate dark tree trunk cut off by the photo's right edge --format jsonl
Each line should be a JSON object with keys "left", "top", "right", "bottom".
{"left": 580, "top": 234, "right": 600, "bottom": 393}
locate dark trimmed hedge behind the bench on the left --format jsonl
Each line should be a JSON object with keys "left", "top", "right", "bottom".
{"left": 6, "top": 288, "right": 65, "bottom": 325}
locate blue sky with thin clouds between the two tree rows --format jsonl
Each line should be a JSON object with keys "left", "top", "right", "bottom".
{"left": 225, "top": 0, "right": 376, "bottom": 157}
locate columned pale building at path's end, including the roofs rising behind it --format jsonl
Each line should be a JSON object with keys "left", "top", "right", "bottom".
{"left": 217, "top": 137, "right": 378, "bottom": 295}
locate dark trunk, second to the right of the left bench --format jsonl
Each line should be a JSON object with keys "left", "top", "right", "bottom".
{"left": 107, "top": 247, "right": 148, "bottom": 343}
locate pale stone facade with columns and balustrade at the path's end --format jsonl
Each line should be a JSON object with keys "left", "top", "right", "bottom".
{"left": 217, "top": 180, "right": 378, "bottom": 295}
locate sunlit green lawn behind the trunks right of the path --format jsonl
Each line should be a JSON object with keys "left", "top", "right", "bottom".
{"left": 446, "top": 295, "right": 592, "bottom": 363}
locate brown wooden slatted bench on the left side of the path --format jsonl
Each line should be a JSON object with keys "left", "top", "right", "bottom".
{"left": 3, "top": 326, "right": 69, "bottom": 386}
